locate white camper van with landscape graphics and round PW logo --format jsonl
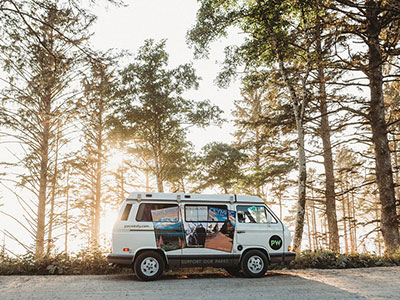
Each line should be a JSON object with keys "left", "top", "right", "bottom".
{"left": 107, "top": 192, "right": 295, "bottom": 280}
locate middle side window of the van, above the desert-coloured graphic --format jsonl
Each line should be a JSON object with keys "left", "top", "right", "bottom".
{"left": 185, "top": 204, "right": 228, "bottom": 222}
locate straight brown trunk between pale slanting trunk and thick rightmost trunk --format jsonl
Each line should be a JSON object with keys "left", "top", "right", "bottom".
{"left": 316, "top": 23, "right": 340, "bottom": 252}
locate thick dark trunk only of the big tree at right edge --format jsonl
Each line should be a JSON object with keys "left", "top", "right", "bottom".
{"left": 366, "top": 3, "right": 400, "bottom": 253}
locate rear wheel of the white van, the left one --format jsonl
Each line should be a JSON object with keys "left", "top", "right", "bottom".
{"left": 133, "top": 251, "right": 165, "bottom": 281}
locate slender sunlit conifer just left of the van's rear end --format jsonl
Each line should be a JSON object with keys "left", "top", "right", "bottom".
{"left": 76, "top": 55, "right": 114, "bottom": 246}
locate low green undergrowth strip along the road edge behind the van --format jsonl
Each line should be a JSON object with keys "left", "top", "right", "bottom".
{"left": 0, "top": 250, "right": 400, "bottom": 275}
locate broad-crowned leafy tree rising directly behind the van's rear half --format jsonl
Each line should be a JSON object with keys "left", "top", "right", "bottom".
{"left": 109, "top": 40, "right": 221, "bottom": 192}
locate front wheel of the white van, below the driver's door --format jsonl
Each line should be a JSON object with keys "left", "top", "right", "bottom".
{"left": 241, "top": 250, "right": 268, "bottom": 278}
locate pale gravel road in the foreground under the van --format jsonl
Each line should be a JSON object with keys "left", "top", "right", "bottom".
{"left": 0, "top": 267, "right": 400, "bottom": 300}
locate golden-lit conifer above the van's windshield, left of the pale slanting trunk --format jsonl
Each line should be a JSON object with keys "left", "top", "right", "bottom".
{"left": 233, "top": 74, "right": 295, "bottom": 197}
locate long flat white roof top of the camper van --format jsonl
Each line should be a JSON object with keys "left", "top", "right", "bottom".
{"left": 127, "top": 192, "right": 264, "bottom": 203}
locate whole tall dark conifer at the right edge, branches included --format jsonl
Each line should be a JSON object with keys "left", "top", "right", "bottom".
{"left": 321, "top": 0, "right": 400, "bottom": 252}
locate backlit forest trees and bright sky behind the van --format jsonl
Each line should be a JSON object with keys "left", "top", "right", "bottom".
{"left": 0, "top": 0, "right": 400, "bottom": 264}
